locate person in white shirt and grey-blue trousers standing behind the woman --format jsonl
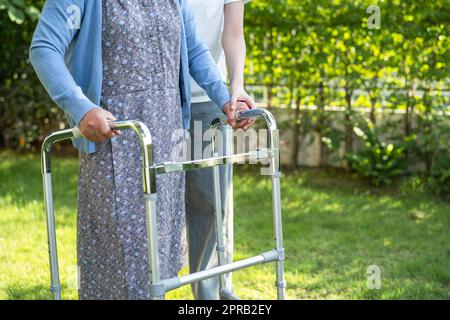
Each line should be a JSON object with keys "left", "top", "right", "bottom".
{"left": 186, "top": 0, "right": 256, "bottom": 300}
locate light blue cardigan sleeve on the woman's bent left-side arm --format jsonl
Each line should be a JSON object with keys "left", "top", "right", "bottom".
{"left": 30, "top": 0, "right": 98, "bottom": 124}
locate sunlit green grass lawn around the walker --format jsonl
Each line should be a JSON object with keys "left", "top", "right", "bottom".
{"left": 0, "top": 152, "right": 450, "bottom": 299}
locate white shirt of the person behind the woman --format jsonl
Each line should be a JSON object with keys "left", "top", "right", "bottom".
{"left": 189, "top": 0, "right": 250, "bottom": 103}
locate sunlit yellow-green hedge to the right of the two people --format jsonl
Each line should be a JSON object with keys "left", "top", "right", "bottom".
{"left": 246, "top": 0, "right": 450, "bottom": 192}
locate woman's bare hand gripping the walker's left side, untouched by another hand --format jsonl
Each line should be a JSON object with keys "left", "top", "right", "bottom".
{"left": 78, "top": 108, "right": 120, "bottom": 142}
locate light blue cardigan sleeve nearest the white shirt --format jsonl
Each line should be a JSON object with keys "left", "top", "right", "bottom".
{"left": 181, "top": 0, "right": 231, "bottom": 108}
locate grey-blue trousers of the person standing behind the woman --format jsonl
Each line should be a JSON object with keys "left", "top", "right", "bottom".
{"left": 186, "top": 102, "right": 233, "bottom": 300}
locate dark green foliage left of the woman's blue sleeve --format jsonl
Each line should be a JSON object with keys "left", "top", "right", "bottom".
{"left": 0, "top": 0, "right": 63, "bottom": 150}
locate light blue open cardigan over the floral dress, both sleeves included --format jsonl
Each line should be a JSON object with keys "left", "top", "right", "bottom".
{"left": 30, "top": 0, "right": 230, "bottom": 153}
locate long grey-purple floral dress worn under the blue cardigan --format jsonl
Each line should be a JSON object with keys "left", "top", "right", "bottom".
{"left": 78, "top": 0, "right": 185, "bottom": 299}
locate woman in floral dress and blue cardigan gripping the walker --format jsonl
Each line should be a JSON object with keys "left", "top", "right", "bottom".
{"left": 30, "top": 0, "right": 251, "bottom": 299}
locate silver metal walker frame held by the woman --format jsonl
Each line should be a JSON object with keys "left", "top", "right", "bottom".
{"left": 41, "top": 109, "right": 286, "bottom": 300}
